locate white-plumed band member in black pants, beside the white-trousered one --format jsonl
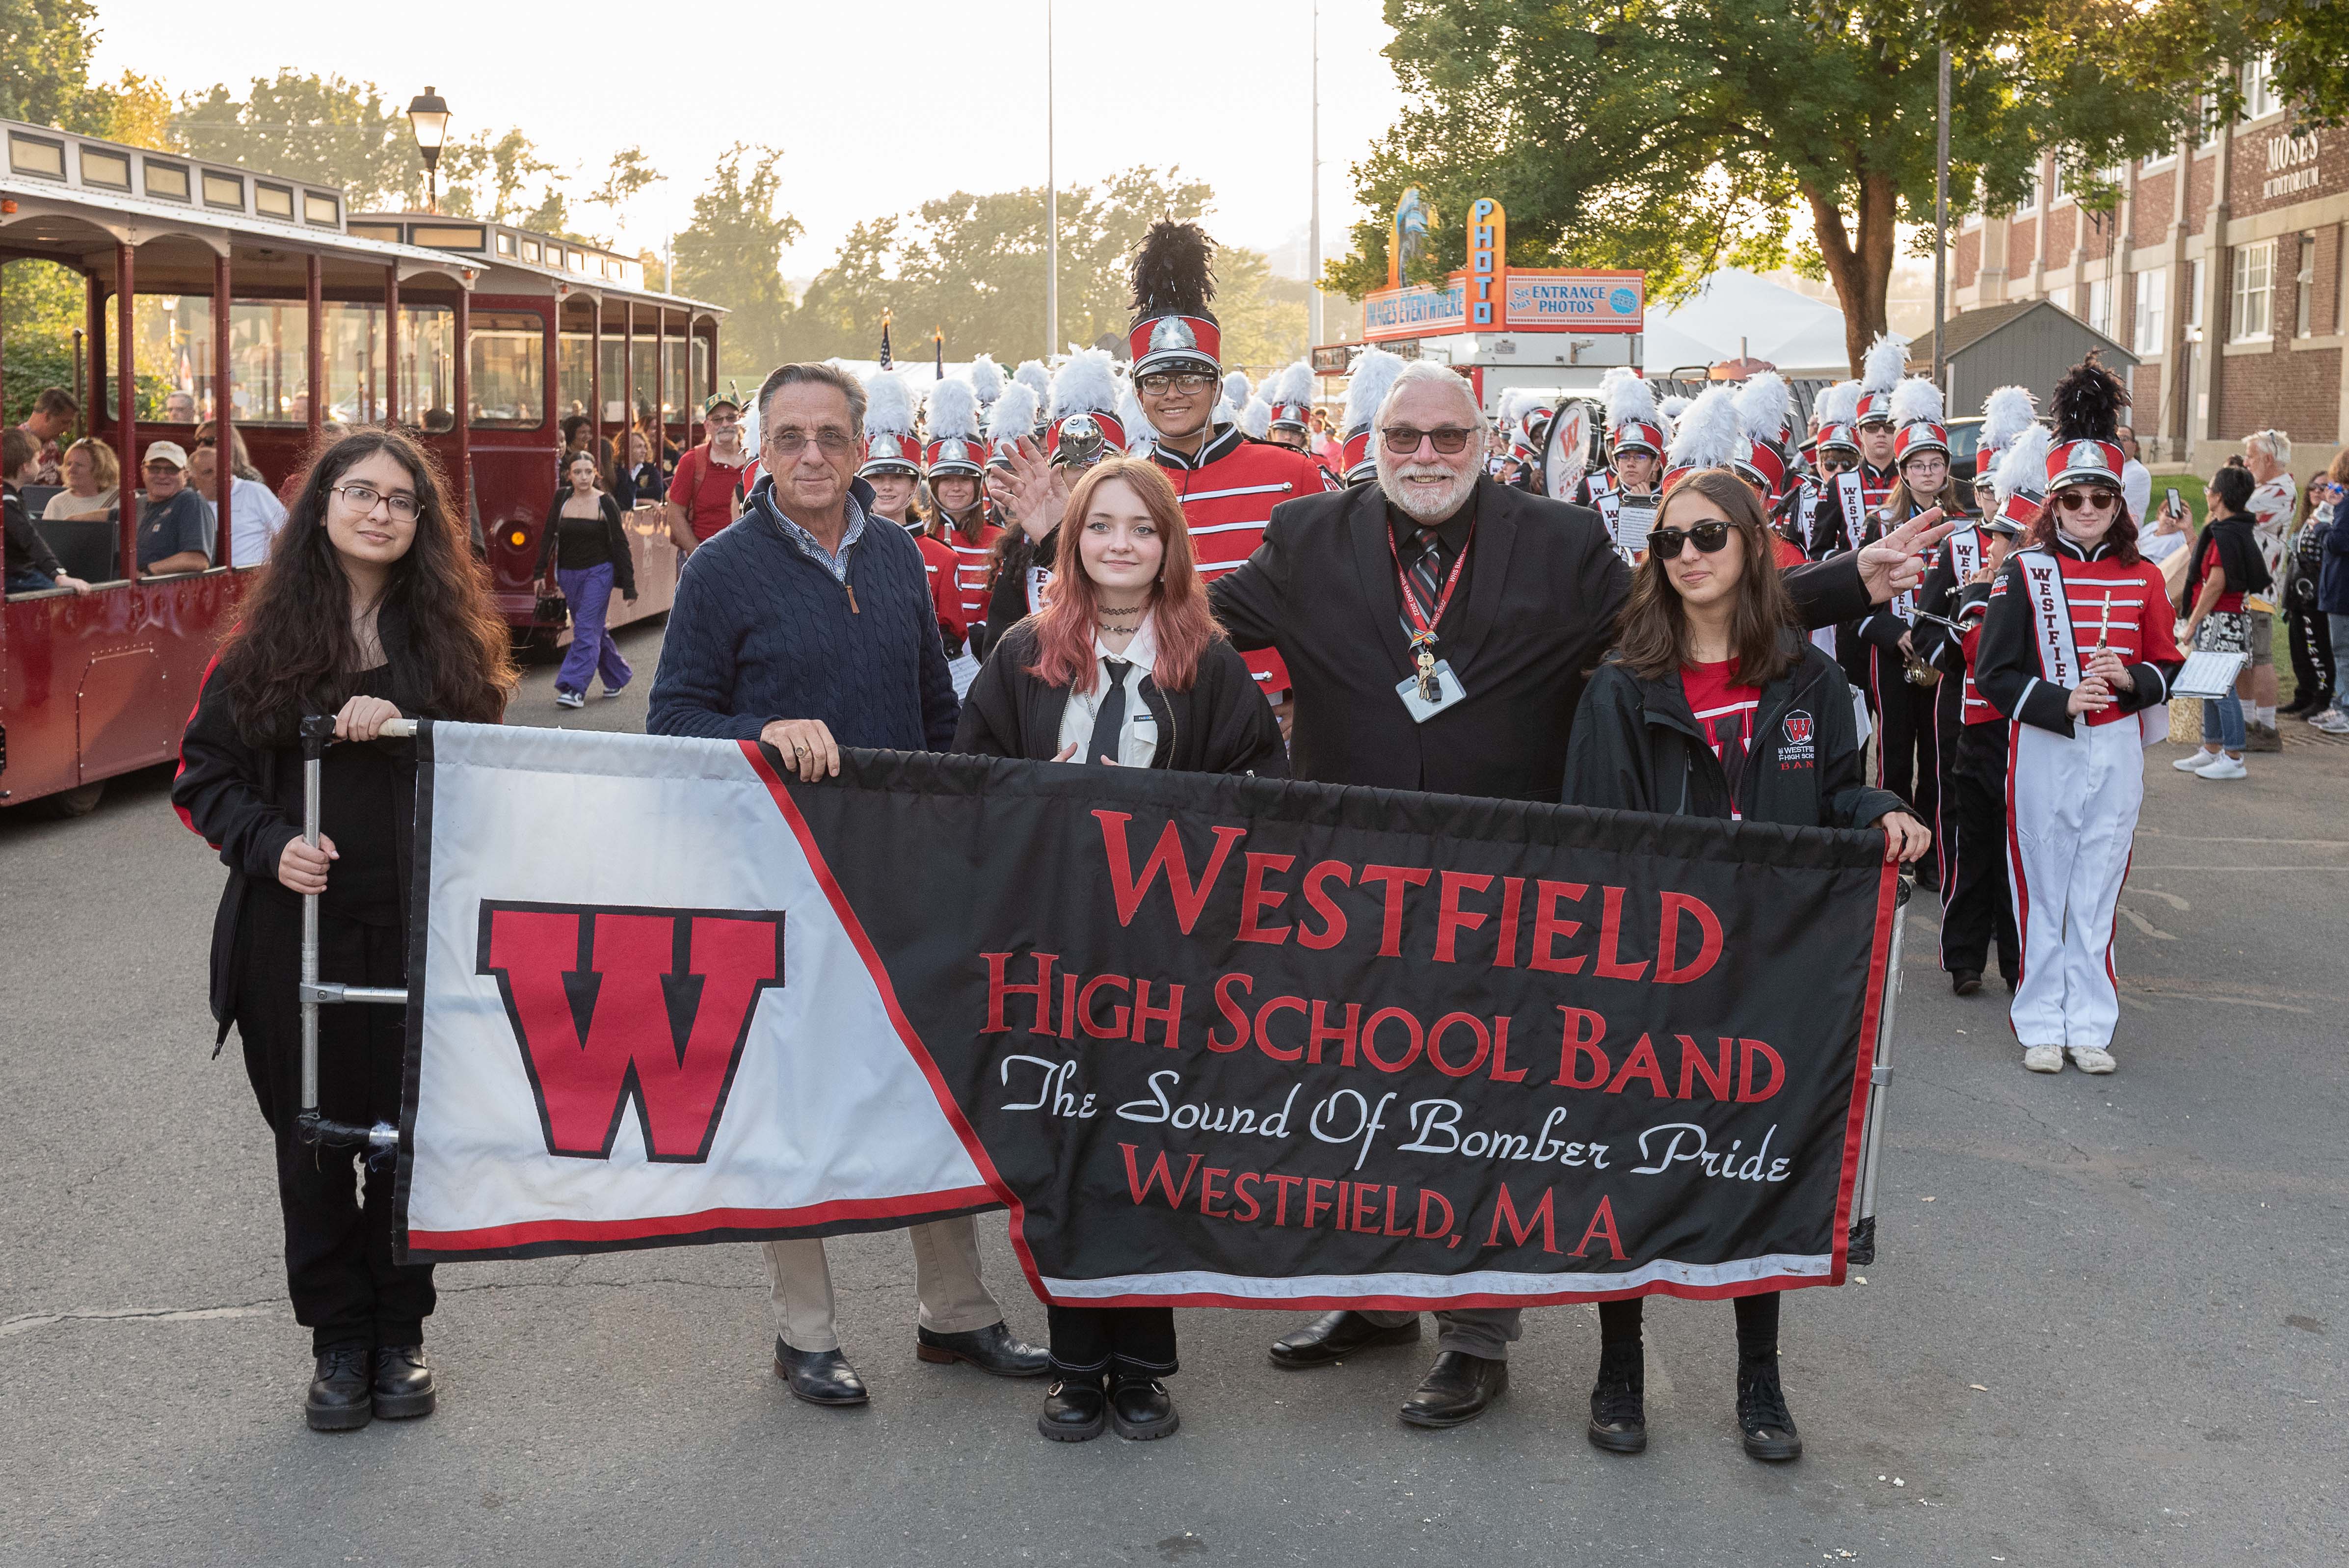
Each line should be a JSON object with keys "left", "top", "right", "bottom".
{"left": 1917, "top": 425, "right": 2048, "bottom": 995}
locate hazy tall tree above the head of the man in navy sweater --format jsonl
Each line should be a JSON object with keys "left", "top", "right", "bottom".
{"left": 672, "top": 141, "right": 801, "bottom": 378}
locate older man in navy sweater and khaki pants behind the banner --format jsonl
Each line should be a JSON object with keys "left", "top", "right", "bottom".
{"left": 648, "top": 364, "right": 1045, "bottom": 1406}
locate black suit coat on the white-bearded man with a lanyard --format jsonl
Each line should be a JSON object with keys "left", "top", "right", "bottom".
{"left": 1207, "top": 479, "right": 1868, "bottom": 803}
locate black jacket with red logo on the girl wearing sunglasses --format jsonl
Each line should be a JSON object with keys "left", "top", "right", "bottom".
{"left": 1564, "top": 634, "right": 1907, "bottom": 828}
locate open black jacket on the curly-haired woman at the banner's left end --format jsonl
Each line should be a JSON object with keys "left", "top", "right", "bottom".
{"left": 171, "top": 606, "right": 430, "bottom": 1040}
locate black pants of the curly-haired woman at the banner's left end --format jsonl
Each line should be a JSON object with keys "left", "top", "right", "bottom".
{"left": 237, "top": 890, "right": 434, "bottom": 1352}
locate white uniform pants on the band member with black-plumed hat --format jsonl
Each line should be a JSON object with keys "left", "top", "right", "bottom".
{"left": 2006, "top": 720, "right": 2145, "bottom": 1049}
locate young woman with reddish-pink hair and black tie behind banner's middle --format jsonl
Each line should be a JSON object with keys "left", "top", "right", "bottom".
{"left": 954, "top": 458, "right": 1290, "bottom": 1444}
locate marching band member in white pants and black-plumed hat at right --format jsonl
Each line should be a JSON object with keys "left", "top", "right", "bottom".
{"left": 1975, "top": 354, "right": 2182, "bottom": 1073}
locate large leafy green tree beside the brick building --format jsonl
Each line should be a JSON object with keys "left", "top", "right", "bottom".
{"left": 1327, "top": 0, "right": 2241, "bottom": 371}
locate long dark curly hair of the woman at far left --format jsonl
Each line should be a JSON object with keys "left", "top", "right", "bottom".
{"left": 214, "top": 425, "right": 517, "bottom": 746}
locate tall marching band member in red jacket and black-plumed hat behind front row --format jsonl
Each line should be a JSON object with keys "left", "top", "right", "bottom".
{"left": 1125, "top": 221, "right": 1330, "bottom": 707}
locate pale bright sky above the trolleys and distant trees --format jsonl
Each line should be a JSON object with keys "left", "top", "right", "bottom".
{"left": 92, "top": 0, "right": 1402, "bottom": 277}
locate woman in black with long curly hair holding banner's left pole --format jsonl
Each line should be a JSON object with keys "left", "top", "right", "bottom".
{"left": 171, "top": 427, "right": 514, "bottom": 1432}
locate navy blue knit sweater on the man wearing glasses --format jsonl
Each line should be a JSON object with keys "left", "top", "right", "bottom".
{"left": 646, "top": 477, "right": 956, "bottom": 751}
